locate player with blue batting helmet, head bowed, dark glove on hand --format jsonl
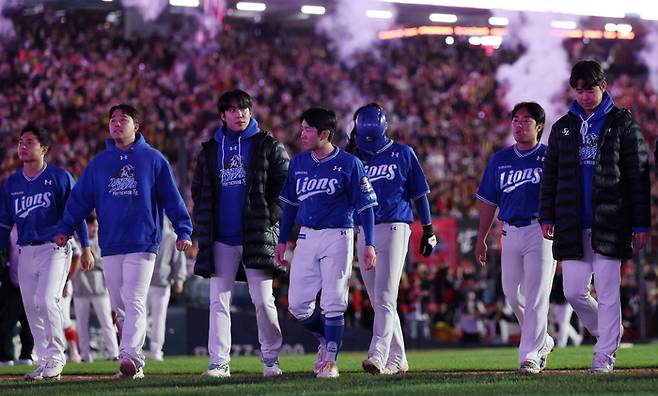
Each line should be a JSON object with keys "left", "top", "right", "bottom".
{"left": 350, "top": 103, "right": 436, "bottom": 374}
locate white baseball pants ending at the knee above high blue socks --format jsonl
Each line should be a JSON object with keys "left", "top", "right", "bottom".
{"left": 288, "top": 227, "right": 354, "bottom": 320}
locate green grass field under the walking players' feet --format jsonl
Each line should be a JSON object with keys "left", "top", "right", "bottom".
{"left": 0, "top": 345, "right": 658, "bottom": 396}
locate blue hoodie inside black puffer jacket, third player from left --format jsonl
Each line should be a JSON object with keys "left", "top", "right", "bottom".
{"left": 215, "top": 118, "right": 260, "bottom": 246}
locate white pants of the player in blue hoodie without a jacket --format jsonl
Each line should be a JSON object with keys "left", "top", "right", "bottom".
{"left": 103, "top": 252, "right": 155, "bottom": 367}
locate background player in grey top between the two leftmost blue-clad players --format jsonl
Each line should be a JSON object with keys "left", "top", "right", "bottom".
{"left": 71, "top": 214, "right": 119, "bottom": 362}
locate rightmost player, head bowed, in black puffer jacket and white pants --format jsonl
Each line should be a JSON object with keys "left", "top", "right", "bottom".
{"left": 540, "top": 60, "right": 651, "bottom": 373}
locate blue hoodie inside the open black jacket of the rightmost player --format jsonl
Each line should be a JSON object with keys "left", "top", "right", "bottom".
{"left": 569, "top": 92, "right": 614, "bottom": 229}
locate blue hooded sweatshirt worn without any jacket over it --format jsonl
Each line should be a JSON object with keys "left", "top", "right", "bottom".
{"left": 58, "top": 133, "right": 192, "bottom": 256}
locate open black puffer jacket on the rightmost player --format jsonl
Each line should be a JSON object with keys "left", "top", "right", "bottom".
{"left": 539, "top": 107, "right": 651, "bottom": 260}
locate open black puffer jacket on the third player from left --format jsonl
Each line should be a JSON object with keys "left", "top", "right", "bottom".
{"left": 192, "top": 132, "right": 290, "bottom": 278}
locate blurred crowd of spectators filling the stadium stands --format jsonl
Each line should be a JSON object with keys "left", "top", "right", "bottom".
{"left": 0, "top": 9, "right": 658, "bottom": 342}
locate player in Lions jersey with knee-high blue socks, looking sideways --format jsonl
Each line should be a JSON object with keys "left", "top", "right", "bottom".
{"left": 275, "top": 108, "right": 377, "bottom": 378}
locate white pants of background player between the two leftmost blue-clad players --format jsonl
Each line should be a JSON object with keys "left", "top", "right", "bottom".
{"left": 73, "top": 294, "right": 119, "bottom": 361}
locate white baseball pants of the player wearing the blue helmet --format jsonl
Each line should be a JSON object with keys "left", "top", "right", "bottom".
{"left": 357, "top": 223, "right": 411, "bottom": 366}
